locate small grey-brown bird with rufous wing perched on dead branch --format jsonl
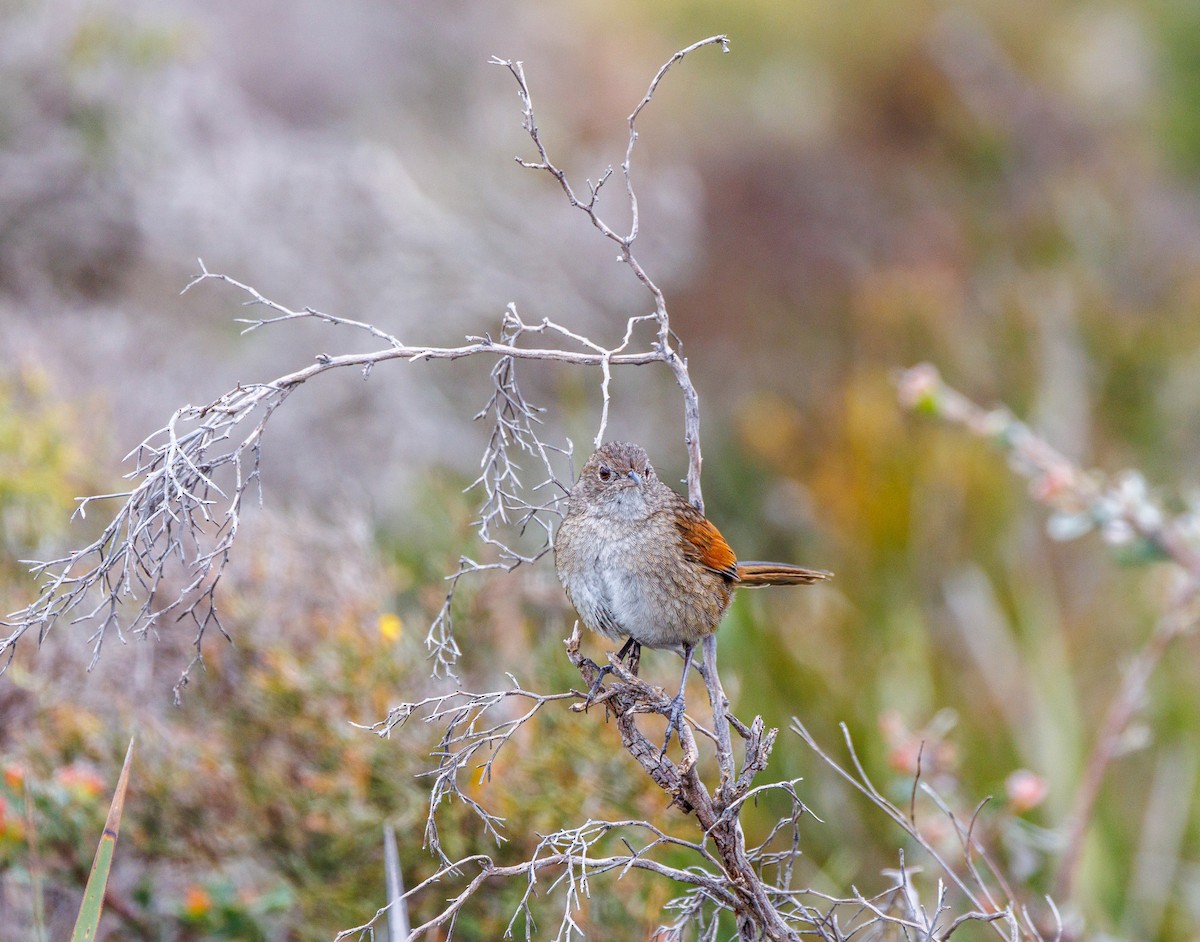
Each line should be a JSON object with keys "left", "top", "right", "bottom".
{"left": 554, "top": 442, "right": 833, "bottom": 754}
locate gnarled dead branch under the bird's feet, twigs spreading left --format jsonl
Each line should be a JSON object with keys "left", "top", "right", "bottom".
{"left": 350, "top": 625, "right": 803, "bottom": 938}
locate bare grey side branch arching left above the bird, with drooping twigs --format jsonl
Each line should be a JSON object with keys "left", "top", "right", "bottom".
{"left": 0, "top": 273, "right": 666, "bottom": 681}
